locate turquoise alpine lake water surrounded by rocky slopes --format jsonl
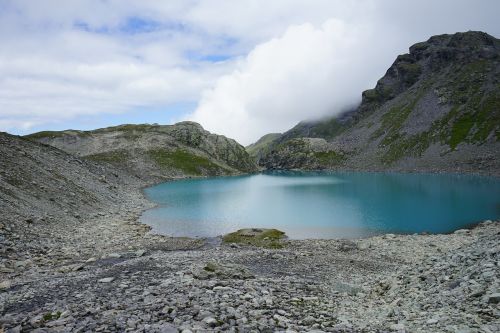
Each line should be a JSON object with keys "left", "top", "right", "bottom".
{"left": 141, "top": 171, "right": 500, "bottom": 239}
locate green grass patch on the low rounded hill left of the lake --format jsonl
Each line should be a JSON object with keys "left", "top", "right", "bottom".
{"left": 148, "top": 148, "right": 230, "bottom": 176}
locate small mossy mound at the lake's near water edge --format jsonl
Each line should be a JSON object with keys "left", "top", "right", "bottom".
{"left": 222, "top": 228, "right": 286, "bottom": 249}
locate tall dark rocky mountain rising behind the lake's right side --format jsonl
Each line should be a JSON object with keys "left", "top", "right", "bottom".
{"left": 259, "top": 31, "right": 500, "bottom": 174}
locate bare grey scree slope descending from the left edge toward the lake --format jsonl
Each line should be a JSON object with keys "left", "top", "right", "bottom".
{"left": 0, "top": 133, "right": 144, "bottom": 255}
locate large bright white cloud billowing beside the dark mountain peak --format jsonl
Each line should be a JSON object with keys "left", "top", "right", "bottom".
{"left": 189, "top": 20, "right": 378, "bottom": 144}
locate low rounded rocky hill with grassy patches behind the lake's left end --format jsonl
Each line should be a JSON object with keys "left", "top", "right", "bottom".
{"left": 27, "top": 122, "right": 256, "bottom": 180}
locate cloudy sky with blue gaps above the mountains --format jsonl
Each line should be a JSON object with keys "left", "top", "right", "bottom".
{"left": 0, "top": 0, "right": 500, "bottom": 145}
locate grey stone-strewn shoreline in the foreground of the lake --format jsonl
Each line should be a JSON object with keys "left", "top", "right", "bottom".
{"left": 0, "top": 171, "right": 500, "bottom": 333}
